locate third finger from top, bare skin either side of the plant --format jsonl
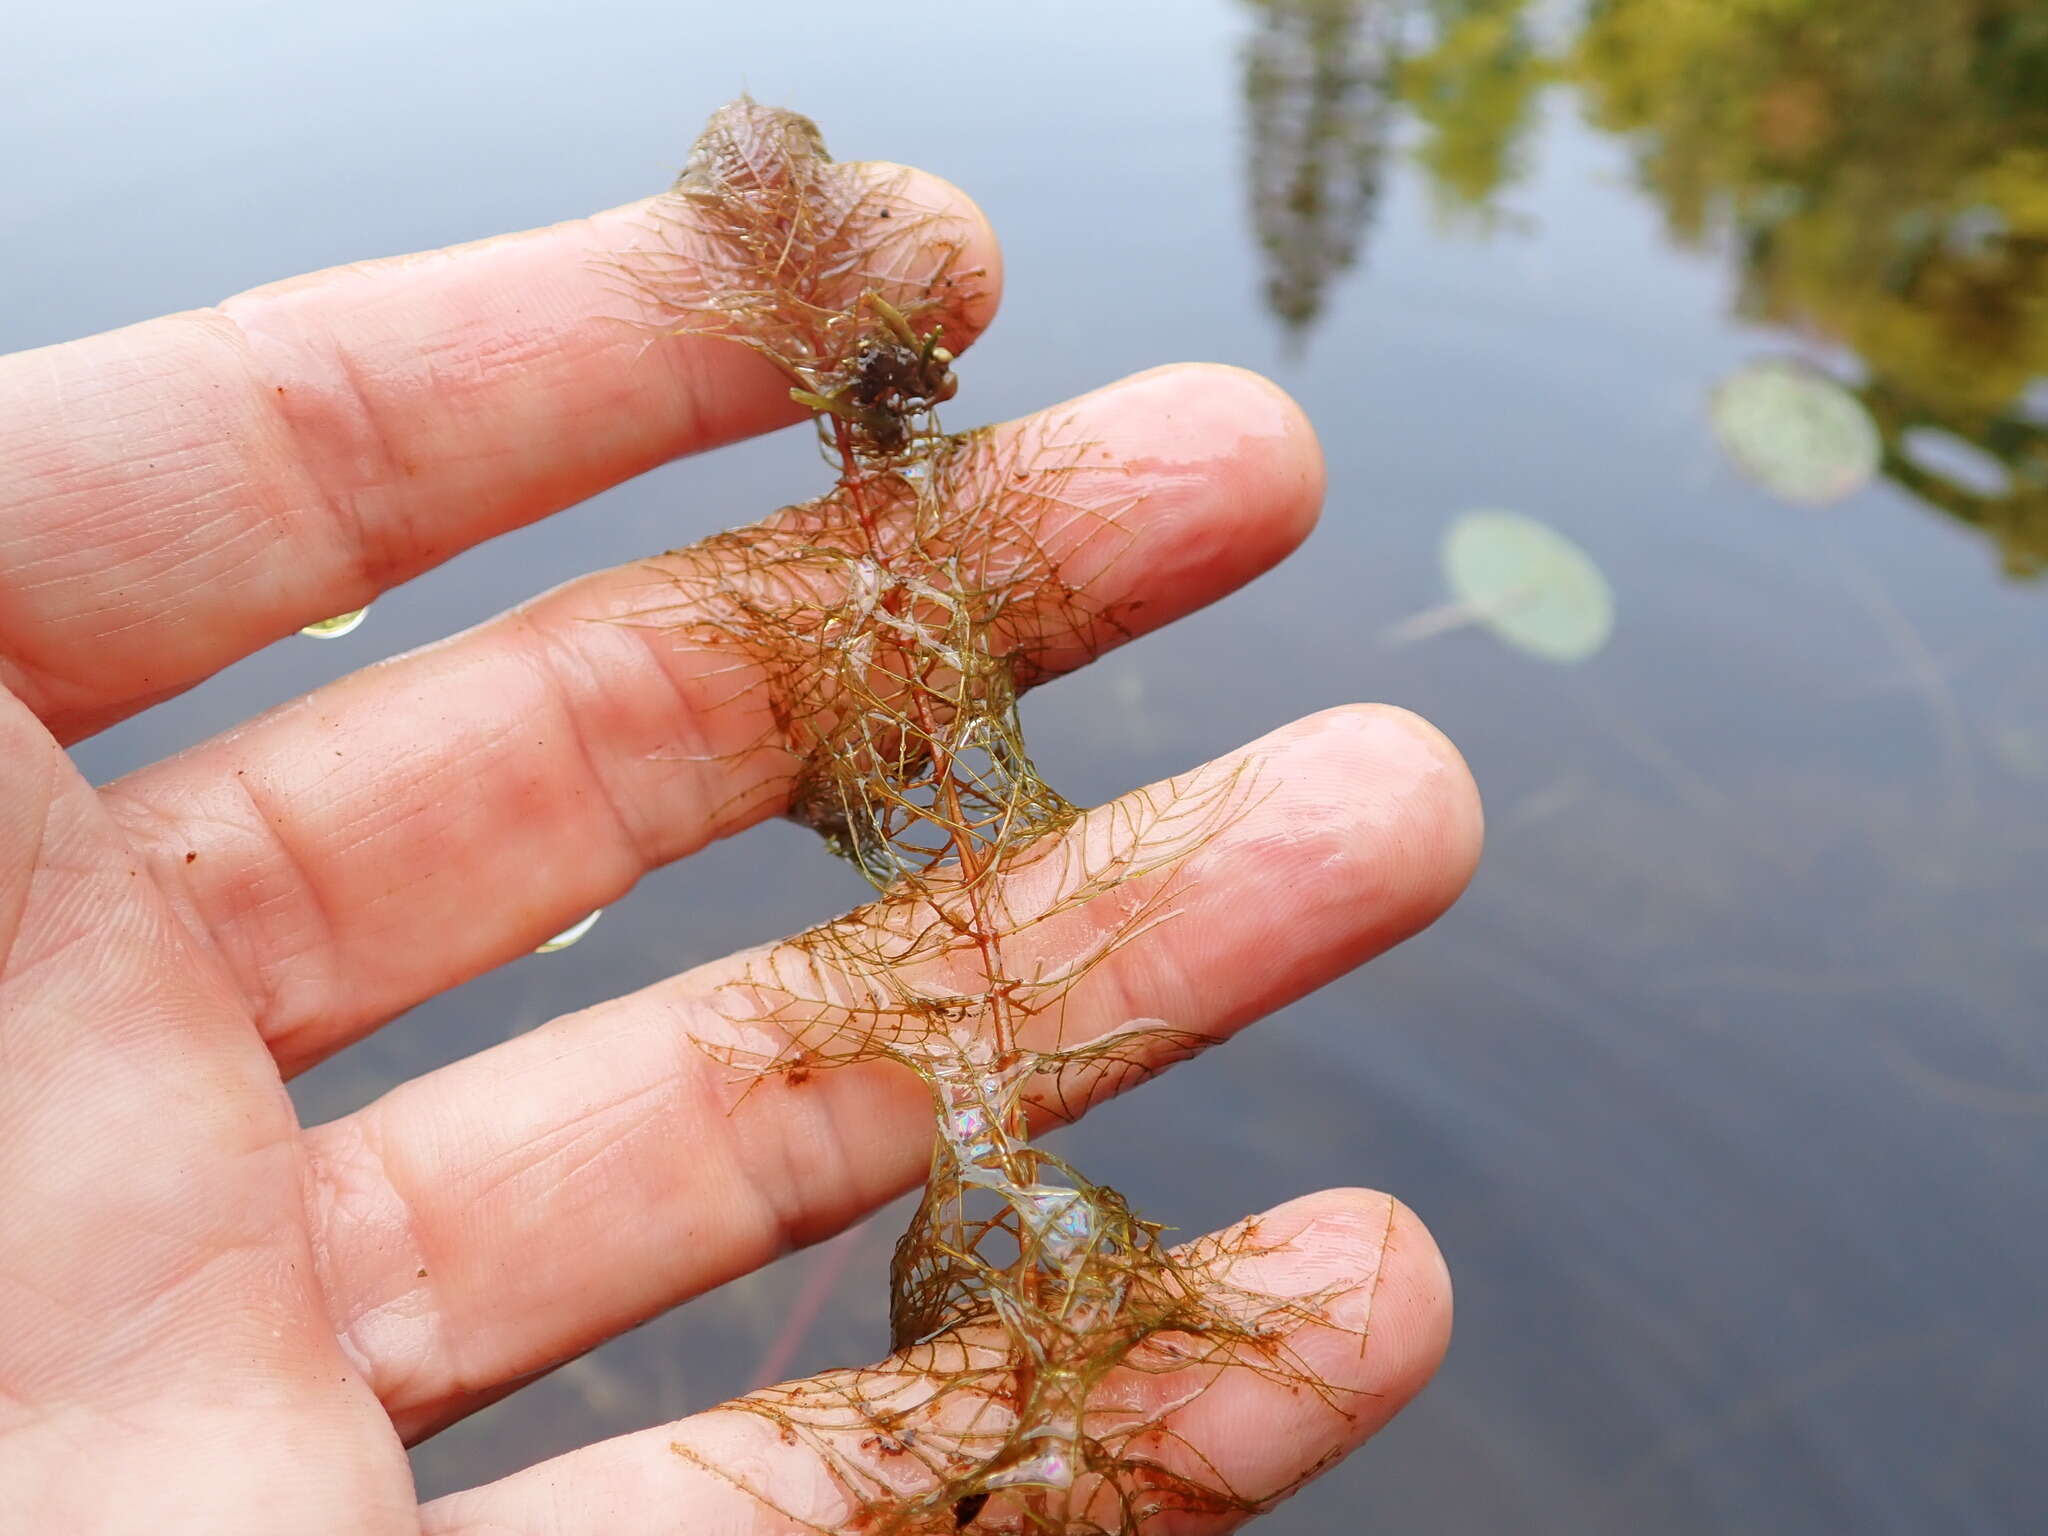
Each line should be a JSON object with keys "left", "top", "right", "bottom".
{"left": 307, "top": 707, "right": 1479, "bottom": 1434}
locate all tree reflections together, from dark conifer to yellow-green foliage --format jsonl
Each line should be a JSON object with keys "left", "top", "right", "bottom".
{"left": 1247, "top": 0, "right": 2048, "bottom": 575}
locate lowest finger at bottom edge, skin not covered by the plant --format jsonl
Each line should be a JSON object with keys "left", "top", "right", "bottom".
{"left": 422, "top": 1190, "right": 1450, "bottom": 1536}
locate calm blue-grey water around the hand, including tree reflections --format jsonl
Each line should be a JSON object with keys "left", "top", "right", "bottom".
{"left": 0, "top": 0, "right": 2048, "bottom": 1532}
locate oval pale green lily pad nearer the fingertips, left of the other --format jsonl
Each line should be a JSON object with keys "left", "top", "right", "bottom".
{"left": 1444, "top": 510, "right": 1614, "bottom": 662}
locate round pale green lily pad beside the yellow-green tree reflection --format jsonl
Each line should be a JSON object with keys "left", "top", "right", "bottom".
{"left": 1708, "top": 358, "right": 1884, "bottom": 506}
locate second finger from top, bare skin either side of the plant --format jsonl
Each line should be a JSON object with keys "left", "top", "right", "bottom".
{"left": 106, "top": 369, "right": 1321, "bottom": 1071}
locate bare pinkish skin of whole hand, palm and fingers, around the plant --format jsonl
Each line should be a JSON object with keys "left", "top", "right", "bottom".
{"left": 0, "top": 162, "right": 1479, "bottom": 1536}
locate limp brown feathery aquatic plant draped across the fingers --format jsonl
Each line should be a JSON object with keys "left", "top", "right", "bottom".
{"left": 618, "top": 100, "right": 1376, "bottom": 1532}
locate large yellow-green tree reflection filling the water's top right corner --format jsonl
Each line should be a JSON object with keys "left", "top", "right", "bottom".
{"left": 1571, "top": 0, "right": 2048, "bottom": 575}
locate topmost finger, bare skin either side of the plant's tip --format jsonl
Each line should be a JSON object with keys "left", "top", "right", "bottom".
{"left": 0, "top": 166, "right": 995, "bottom": 739}
